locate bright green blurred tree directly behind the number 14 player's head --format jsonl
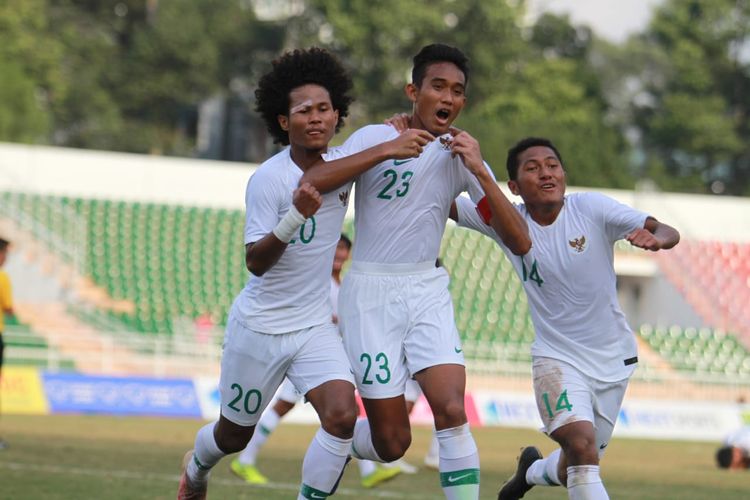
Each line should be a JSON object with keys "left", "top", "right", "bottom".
{"left": 472, "top": 59, "right": 633, "bottom": 188}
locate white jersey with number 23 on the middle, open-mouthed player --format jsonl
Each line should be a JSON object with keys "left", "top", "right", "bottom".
{"left": 342, "top": 125, "right": 494, "bottom": 264}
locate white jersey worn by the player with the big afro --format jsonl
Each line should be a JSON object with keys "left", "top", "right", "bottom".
{"left": 231, "top": 148, "right": 352, "bottom": 333}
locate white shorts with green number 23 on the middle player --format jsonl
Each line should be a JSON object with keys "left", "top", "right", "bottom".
{"left": 339, "top": 262, "right": 464, "bottom": 399}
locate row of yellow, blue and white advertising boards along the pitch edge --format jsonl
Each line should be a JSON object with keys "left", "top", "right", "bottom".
{"left": 0, "top": 367, "right": 750, "bottom": 441}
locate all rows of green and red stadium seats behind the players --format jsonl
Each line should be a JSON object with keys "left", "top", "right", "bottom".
{"left": 7, "top": 193, "right": 750, "bottom": 377}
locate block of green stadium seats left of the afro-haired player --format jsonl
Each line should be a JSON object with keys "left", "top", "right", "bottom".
{"left": 2, "top": 193, "right": 247, "bottom": 333}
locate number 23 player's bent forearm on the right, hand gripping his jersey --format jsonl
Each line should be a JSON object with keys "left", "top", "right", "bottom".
{"left": 451, "top": 129, "right": 531, "bottom": 255}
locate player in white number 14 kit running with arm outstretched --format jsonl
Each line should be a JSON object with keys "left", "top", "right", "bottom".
{"left": 451, "top": 137, "right": 680, "bottom": 500}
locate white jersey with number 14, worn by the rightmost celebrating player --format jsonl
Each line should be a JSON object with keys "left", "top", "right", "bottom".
{"left": 456, "top": 193, "right": 648, "bottom": 382}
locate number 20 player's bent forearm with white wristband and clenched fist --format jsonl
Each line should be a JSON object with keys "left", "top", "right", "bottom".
{"left": 245, "top": 183, "right": 323, "bottom": 276}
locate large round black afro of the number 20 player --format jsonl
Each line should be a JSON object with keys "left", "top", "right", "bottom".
{"left": 255, "top": 47, "right": 354, "bottom": 146}
